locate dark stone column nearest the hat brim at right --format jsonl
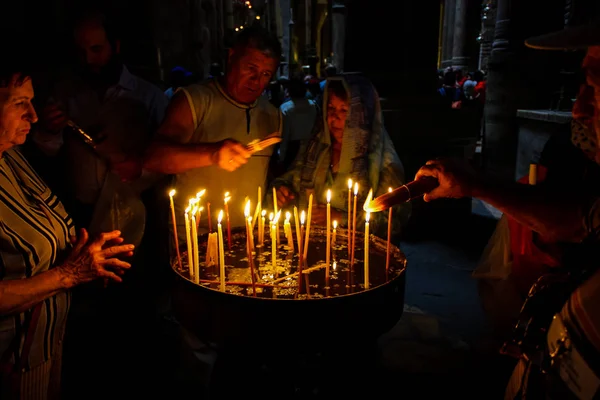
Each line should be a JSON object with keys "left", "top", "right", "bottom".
{"left": 482, "top": 0, "right": 519, "bottom": 180}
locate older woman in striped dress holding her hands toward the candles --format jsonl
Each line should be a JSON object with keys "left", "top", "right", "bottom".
{"left": 0, "top": 58, "right": 133, "bottom": 399}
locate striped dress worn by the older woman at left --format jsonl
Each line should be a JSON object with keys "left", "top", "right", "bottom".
{"left": 0, "top": 148, "right": 75, "bottom": 398}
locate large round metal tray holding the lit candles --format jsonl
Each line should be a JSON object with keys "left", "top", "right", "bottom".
{"left": 172, "top": 226, "right": 406, "bottom": 351}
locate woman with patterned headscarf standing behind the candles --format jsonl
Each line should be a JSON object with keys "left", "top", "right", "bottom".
{"left": 267, "top": 74, "right": 410, "bottom": 236}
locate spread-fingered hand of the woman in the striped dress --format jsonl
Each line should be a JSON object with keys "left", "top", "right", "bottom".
{"left": 58, "top": 229, "right": 134, "bottom": 287}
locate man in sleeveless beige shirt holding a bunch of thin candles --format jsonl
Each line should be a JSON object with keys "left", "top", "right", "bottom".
{"left": 144, "top": 28, "right": 281, "bottom": 238}
